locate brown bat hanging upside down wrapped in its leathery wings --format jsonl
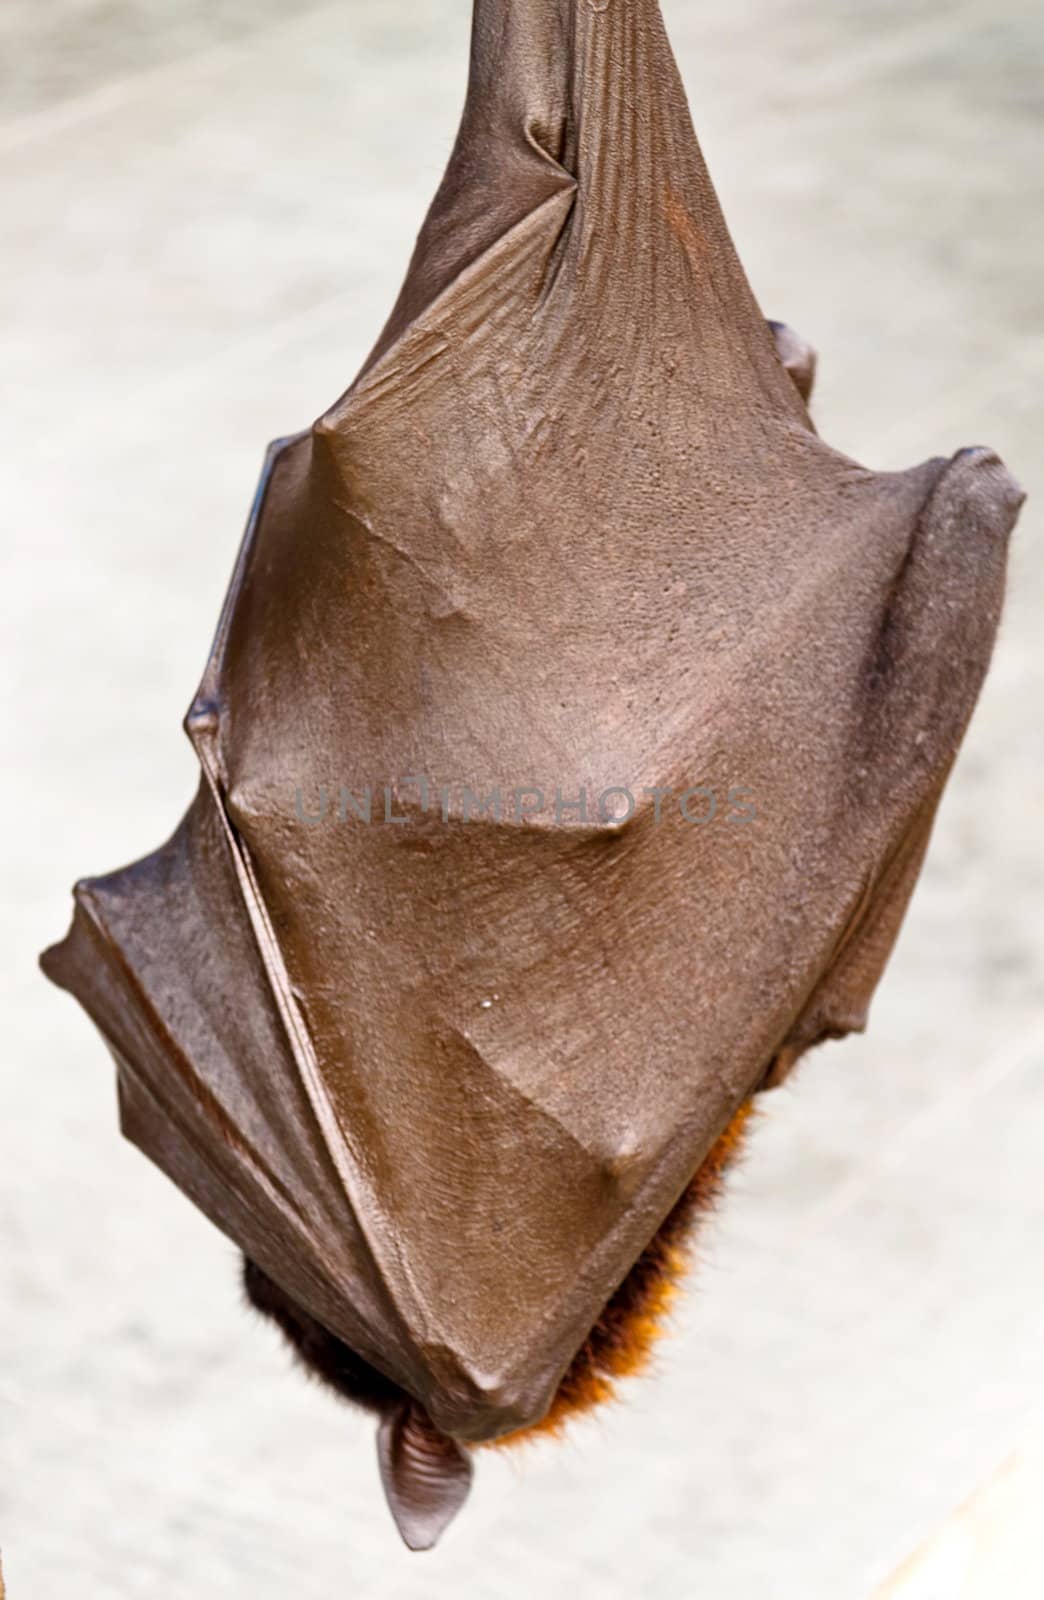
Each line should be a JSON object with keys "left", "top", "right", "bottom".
{"left": 45, "top": 0, "right": 1022, "bottom": 1549}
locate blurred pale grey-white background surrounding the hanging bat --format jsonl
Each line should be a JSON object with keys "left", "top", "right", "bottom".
{"left": 0, "top": 0, "right": 1044, "bottom": 1600}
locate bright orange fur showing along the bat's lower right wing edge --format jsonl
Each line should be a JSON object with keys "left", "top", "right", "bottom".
{"left": 492, "top": 1101, "right": 754, "bottom": 1448}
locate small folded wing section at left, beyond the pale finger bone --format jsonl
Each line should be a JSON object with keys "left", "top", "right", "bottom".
{"left": 43, "top": 786, "right": 416, "bottom": 1382}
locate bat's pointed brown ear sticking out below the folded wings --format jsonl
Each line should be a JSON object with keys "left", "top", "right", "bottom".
{"left": 378, "top": 1400, "right": 471, "bottom": 1550}
